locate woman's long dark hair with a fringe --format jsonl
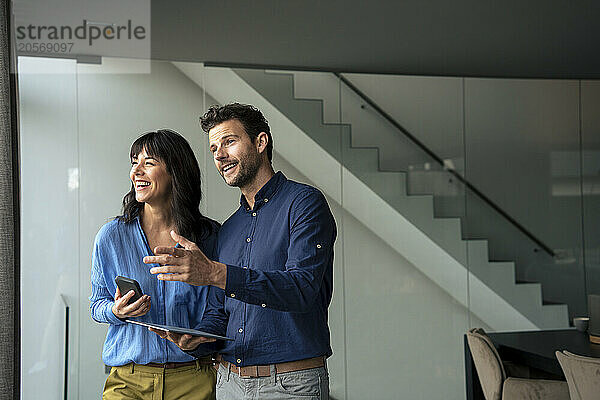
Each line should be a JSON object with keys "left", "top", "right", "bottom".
{"left": 118, "top": 129, "right": 214, "bottom": 244}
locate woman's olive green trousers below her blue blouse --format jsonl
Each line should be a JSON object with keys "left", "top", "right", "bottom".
{"left": 102, "top": 362, "right": 216, "bottom": 400}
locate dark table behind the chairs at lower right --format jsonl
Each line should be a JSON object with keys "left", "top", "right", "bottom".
{"left": 464, "top": 329, "right": 600, "bottom": 400}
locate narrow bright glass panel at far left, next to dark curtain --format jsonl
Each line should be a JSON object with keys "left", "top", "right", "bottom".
{"left": 18, "top": 57, "right": 80, "bottom": 399}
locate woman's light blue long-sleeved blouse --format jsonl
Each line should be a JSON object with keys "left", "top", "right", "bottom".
{"left": 90, "top": 218, "right": 218, "bottom": 366}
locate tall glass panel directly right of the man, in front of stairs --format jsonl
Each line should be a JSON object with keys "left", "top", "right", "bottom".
{"left": 341, "top": 74, "right": 476, "bottom": 399}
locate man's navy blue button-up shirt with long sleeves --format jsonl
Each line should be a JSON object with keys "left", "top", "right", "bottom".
{"left": 200, "top": 172, "right": 336, "bottom": 366}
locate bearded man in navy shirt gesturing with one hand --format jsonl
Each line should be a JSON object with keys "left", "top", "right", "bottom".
{"left": 145, "top": 103, "right": 336, "bottom": 399}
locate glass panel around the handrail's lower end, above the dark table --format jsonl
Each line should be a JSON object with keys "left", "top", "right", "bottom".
{"left": 464, "top": 79, "right": 585, "bottom": 330}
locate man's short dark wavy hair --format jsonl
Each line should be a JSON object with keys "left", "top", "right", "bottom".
{"left": 200, "top": 103, "right": 273, "bottom": 162}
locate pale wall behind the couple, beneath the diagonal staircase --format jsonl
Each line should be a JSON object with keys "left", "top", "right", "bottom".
{"left": 20, "top": 59, "right": 483, "bottom": 399}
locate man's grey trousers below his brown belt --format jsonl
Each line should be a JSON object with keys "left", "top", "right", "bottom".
{"left": 217, "top": 365, "right": 329, "bottom": 400}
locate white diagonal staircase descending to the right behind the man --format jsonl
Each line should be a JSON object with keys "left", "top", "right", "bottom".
{"left": 174, "top": 63, "right": 568, "bottom": 330}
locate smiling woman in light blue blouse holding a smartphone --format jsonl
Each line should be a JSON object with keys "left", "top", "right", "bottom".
{"left": 90, "top": 130, "right": 219, "bottom": 400}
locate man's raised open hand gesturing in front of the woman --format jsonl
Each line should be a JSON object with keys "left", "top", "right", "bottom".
{"left": 144, "top": 231, "right": 227, "bottom": 289}
